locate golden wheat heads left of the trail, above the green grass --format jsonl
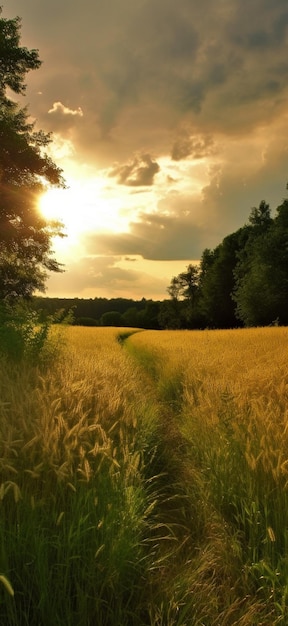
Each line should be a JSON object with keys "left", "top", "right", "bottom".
{"left": 0, "top": 327, "right": 145, "bottom": 490}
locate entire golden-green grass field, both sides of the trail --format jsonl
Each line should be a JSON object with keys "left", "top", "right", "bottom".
{"left": 0, "top": 327, "right": 288, "bottom": 626}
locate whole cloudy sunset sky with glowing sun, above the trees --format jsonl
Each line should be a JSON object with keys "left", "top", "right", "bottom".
{"left": 2, "top": 0, "right": 288, "bottom": 300}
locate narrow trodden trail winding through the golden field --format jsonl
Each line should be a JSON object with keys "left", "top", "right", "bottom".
{"left": 119, "top": 331, "right": 205, "bottom": 575}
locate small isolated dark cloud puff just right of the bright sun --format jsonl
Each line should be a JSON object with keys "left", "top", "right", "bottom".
{"left": 109, "top": 154, "right": 160, "bottom": 187}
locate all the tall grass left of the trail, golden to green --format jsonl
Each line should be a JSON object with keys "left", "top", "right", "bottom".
{"left": 0, "top": 328, "right": 163, "bottom": 626}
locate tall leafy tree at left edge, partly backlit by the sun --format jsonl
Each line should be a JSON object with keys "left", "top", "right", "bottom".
{"left": 0, "top": 8, "right": 65, "bottom": 300}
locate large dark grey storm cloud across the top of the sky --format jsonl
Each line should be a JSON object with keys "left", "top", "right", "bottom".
{"left": 4, "top": 0, "right": 288, "bottom": 155}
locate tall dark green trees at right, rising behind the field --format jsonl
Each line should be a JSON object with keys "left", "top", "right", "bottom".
{"left": 161, "top": 199, "right": 288, "bottom": 328}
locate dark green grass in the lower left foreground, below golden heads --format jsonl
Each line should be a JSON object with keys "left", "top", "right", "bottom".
{"left": 0, "top": 476, "right": 153, "bottom": 626}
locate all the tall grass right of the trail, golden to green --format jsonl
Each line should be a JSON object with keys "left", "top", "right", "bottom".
{"left": 129, "top": 328, "right": 288, "bottom": 624}
